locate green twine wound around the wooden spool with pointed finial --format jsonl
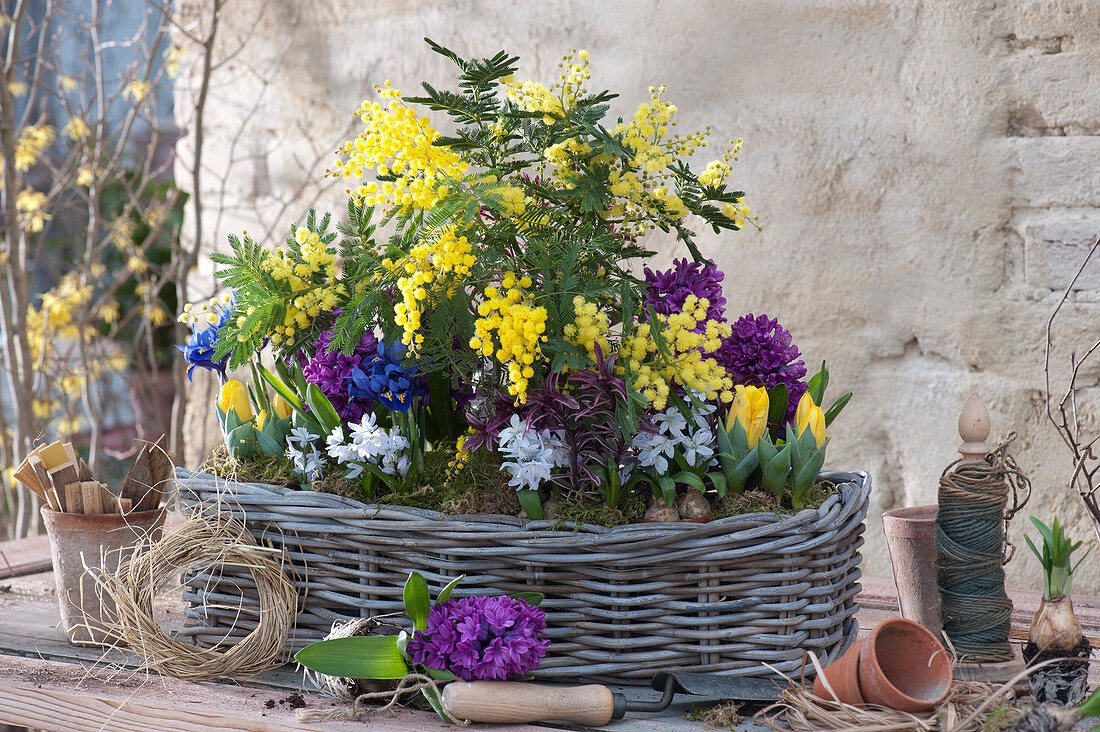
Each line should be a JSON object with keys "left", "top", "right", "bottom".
{"left": 936, "top": 433, "right": 1031, "bottom": 662}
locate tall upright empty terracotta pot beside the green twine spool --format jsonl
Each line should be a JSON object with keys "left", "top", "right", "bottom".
{"left": 882, "top": 504, "right": 943, "bottom": 636}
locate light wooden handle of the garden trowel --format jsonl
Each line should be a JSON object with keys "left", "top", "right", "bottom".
{"left": 442, "top": 681, "right": 623, "bottom": 726}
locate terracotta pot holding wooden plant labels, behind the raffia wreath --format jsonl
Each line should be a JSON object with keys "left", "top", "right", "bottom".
{"left": 42, "top": 506, "right": 164, "bottom": 645}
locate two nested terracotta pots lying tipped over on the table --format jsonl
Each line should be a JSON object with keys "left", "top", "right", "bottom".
{"left": 814, "top": 618, "right": 952, "bottom": 712}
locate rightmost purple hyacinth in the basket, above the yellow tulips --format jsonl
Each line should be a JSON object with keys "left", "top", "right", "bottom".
{"left": 714, "top": 313, "right": 806, "bottom": 423}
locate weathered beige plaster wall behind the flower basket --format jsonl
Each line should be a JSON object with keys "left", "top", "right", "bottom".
{"left": 179, "top": 0, "right": 1100, "bottom": 592}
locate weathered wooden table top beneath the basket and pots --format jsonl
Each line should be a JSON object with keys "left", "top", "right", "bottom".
{"left": 0, "top": 537, "right": 1100, "bottom": 732}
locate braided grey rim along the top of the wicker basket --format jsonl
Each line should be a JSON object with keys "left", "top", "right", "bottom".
{"left": 175, "top": 468, "right": 871, "bottom": 542}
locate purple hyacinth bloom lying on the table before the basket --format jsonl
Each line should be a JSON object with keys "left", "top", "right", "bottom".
{"left": 407, "top": 596, "right": 550, "bottom": 681}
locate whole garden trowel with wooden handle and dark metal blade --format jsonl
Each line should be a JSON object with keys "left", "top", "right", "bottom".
{"left": 442, "top": 671, "right": 788, "bottom": 726}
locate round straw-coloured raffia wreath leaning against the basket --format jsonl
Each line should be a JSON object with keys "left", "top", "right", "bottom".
{"left": 96, "top": 508, "right": 298, "bottom": 681}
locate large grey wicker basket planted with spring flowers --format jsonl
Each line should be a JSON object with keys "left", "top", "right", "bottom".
{"left": 177, "top": 470, "right": 871, "bottom": 684}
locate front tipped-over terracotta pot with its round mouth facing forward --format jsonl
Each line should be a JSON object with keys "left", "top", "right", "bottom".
{"left": 859, "top": 618, "right": 952, "bottom": 712}
